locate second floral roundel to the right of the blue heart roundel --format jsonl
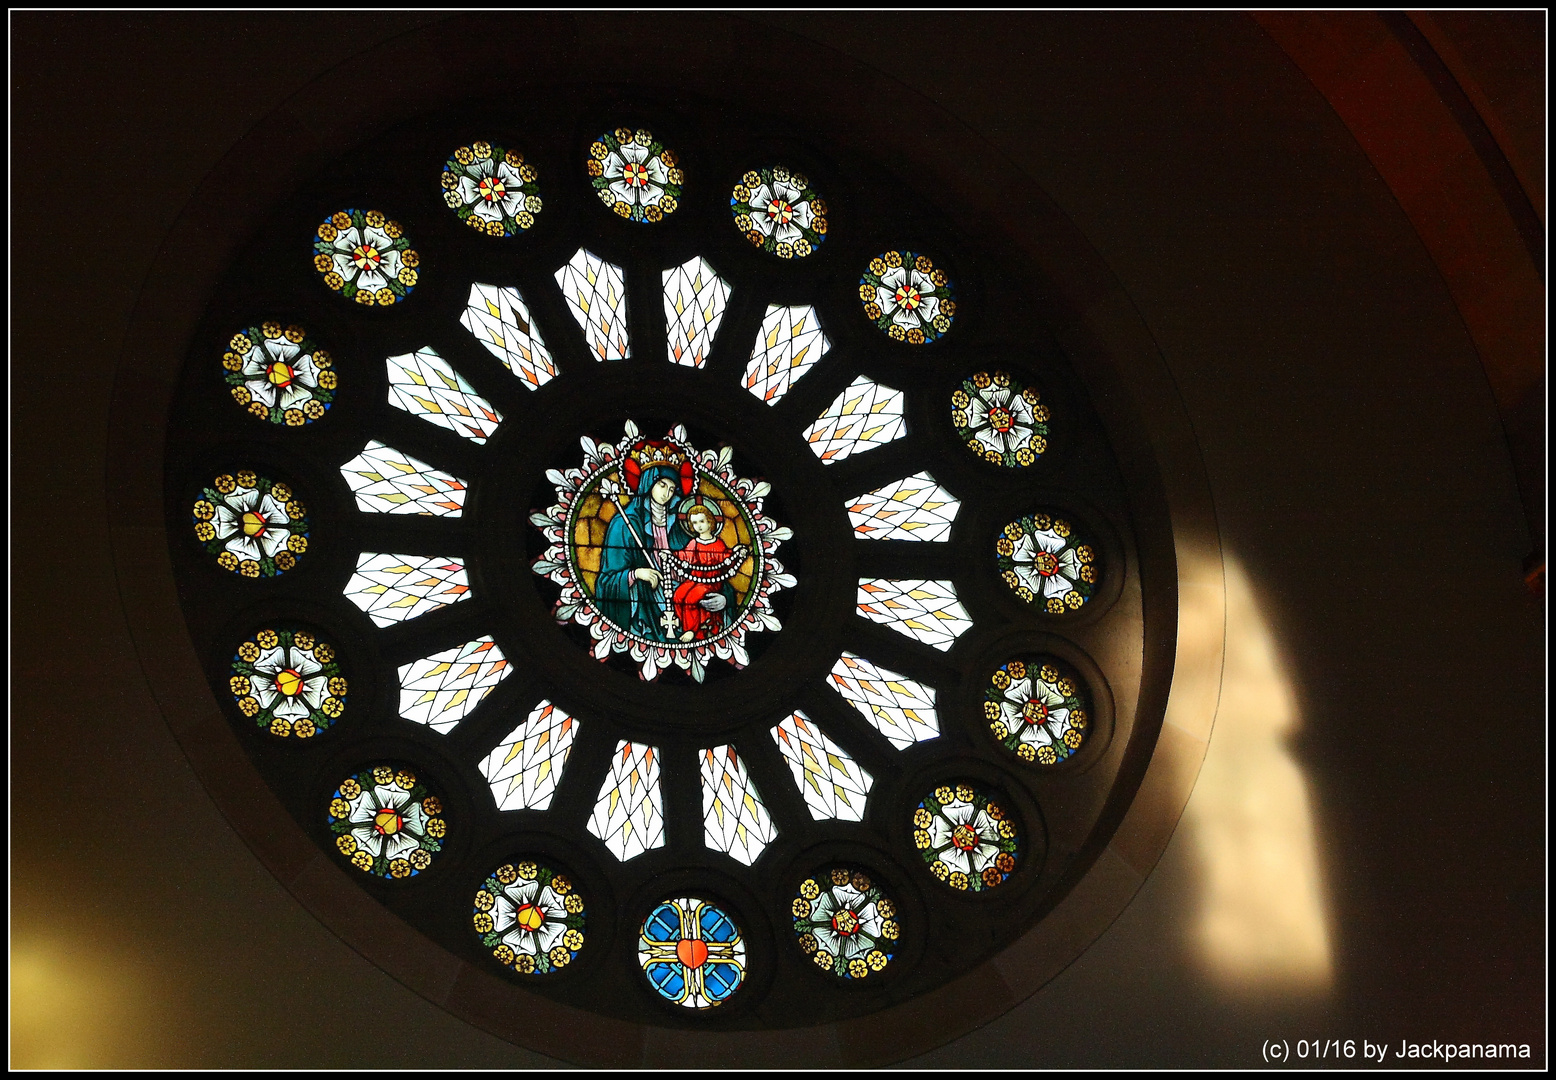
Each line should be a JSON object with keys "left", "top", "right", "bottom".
{"left": 913, "top": 784, "right": 1021, "bottom": 892}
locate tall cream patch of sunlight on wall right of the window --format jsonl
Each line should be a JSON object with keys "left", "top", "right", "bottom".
{"left": 1184, "top": 556, "right": 1332, "bottom": 991}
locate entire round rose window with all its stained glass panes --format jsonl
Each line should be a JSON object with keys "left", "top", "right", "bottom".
{"left": 168, "top": 101, "right": 1142, "bottom": 1029}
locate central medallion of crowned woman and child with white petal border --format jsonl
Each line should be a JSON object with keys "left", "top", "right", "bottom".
{"left": 531, "top": 420, "right": 794, "bottom": 682}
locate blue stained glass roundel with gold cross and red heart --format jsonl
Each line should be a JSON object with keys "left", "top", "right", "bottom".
{"left": 638, "top": 896, "right": 745, "bottom": 1008}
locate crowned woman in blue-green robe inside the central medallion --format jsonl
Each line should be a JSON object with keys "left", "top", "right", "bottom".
{"left": 594, "top": 464, "right": 691, "bottom": 641}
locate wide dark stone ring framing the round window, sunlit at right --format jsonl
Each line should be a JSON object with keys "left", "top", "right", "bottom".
{"left": 110, "top": 16, "right": 1223, "bottom": 1064}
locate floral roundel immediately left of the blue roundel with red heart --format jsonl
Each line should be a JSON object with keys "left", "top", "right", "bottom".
{"left": 470, "top": 861, "right": 587, "bottom": 976}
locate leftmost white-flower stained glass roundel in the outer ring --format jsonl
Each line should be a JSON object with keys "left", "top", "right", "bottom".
{"left": 195, "top": 470, "right": 308, "bottom": 577}
